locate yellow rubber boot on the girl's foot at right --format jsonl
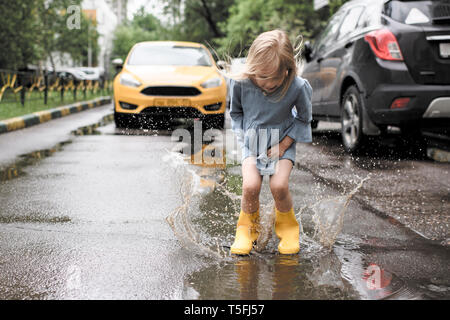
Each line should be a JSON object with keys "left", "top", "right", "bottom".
{"left": 275, "top": 207, "right": 300, "bottom": 254}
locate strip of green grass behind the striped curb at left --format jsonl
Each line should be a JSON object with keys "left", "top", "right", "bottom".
{"left": 0, "top": 90, "right": 108, "bottom": 120}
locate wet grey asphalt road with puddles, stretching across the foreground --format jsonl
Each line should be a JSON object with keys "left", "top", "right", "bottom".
{"left": 0, "top": 106, "right": 450, "bottom": 299}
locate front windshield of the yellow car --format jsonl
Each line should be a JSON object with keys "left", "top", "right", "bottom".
{"left": 128, "top": 45, "right": 211, "bottom": 67}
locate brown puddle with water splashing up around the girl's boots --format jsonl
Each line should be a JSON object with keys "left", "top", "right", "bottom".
{"left": 165, "top": 146, "right": 448, "bottom": 300}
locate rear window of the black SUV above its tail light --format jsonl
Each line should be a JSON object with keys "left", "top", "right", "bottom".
{"left": 383, "top": 0, "right": 450, "bottom": 25}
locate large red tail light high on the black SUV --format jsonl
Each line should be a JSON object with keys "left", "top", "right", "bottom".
{"left": 364, "top": 29, "right": 403, "bottom": 61}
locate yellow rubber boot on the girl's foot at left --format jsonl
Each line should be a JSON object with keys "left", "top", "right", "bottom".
{"left": 231, "top": 208, "right": 259, "bottom": 254}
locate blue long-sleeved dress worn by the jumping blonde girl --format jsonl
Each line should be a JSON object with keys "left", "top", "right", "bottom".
{"left": 228, "top": 76, "right": 312, "bottom": 175}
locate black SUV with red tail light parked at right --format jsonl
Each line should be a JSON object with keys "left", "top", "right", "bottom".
{"left": 302, "top": 0, "right": 450, "bottom": 152}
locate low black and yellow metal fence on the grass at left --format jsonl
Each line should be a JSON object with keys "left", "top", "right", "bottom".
{"left": 0, "top": 69, "right": 112, "bottom": 106}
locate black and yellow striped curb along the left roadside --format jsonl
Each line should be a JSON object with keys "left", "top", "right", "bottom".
{"left": 0, "top": 96, "right": 111, "bottom": 134}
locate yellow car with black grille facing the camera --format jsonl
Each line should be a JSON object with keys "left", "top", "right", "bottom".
{"left": 114, "top": 41, "right": 227, "bottom": 128}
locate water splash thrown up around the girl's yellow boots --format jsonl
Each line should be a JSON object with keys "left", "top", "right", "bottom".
{"left": 165, "top": 144, "right": 370, "bottom": 259}
